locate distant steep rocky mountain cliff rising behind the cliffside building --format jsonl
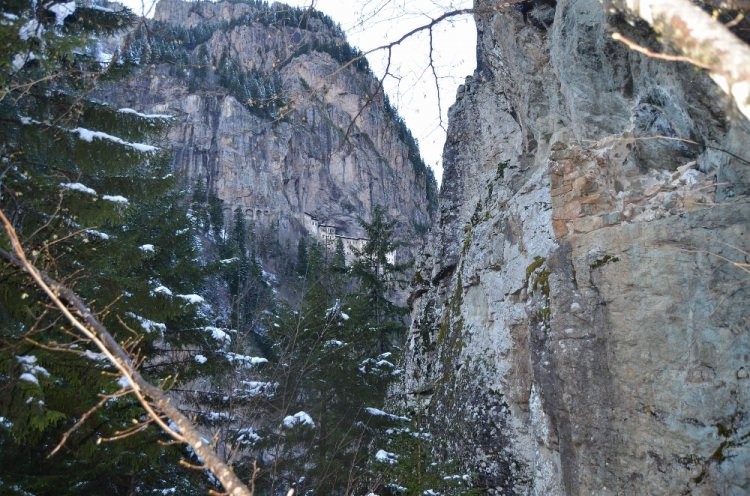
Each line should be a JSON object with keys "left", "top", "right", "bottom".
{"left": 106, "top": 0, "right": 437, "bottom": 264}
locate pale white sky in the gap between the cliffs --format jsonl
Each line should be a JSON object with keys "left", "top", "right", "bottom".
{"left": 120, "top": 0, "right": 476, "bottom": 182}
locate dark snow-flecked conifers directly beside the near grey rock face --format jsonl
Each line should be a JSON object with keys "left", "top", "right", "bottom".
{"left": 245, "top": 208, "right": 414, "bottom": 494}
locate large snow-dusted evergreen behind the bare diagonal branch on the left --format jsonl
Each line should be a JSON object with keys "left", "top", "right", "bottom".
{"left": 0, "top": 0, "right": 241, "bottom": 495}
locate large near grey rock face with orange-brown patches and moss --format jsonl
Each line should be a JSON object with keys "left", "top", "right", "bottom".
{"left": 398, "top": 0, "right": 750, "bottom": 495}
